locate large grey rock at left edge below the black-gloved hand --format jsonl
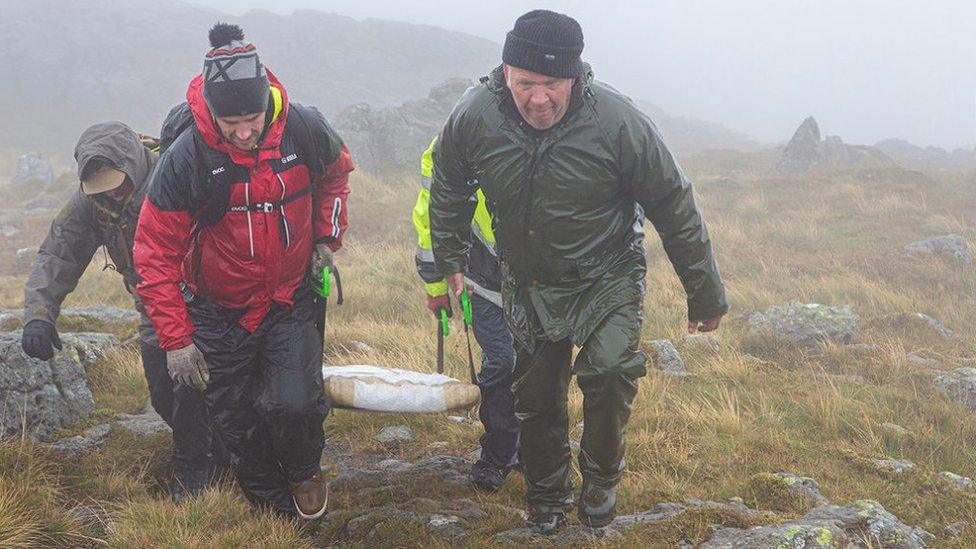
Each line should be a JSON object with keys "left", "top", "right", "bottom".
{"left": 0, "top": 330, "right": 118, "bottom": 441}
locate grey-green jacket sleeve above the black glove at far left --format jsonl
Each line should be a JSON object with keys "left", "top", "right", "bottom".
{"left": 24, "top": 190, "right": 102, "bottom": 324}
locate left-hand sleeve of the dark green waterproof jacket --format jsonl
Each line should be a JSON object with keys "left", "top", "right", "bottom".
{"left": 430, "top": 109, "right": 478, "bottom": 276}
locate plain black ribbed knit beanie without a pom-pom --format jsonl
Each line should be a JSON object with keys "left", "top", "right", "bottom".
{"left": 502, "top": 10, "right": 583, "bottom": 78}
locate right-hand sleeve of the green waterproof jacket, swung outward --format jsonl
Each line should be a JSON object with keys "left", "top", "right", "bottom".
{"left": 619, "top": 112, "right": 729, "bottom": 321}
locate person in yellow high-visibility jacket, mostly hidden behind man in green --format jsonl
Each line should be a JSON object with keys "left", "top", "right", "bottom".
{"left": 413, "top": 137, "right": 518, "bottom": 492}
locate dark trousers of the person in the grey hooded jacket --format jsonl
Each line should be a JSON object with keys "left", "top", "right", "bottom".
{"left": 139, "top": 341, "right": 227, "bottom": 480}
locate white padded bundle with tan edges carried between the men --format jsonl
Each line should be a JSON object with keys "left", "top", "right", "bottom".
{"left": 322, "top": 365, "right": 481, "bottom": 413}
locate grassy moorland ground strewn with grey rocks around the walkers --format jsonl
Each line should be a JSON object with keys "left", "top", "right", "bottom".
{"left": 0, "top": 162, "right": 976, "bottom": 548}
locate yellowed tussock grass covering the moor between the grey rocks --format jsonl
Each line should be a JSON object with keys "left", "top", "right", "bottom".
{"left": 0, "top": 165, "right": 976, "bottom": 547}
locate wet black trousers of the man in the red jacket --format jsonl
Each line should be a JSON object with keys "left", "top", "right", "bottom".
{"left": 188, "top": 286, "right": 329, "bottom": 514}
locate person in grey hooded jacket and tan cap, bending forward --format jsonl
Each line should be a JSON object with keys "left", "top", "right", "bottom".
{"left": 21, "top": 122, "right": 222, "bottom": 501}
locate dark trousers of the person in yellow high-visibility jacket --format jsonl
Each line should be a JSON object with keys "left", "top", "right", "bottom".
{"left": 471, "top": 294, "right": 519, "bottom": 469}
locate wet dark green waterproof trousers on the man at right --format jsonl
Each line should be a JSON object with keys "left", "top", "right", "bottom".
{"left": 512, "top": 302, "right": 646, "bottom": 512}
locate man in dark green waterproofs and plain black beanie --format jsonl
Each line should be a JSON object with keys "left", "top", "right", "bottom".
{"left": 430, "top": 10, "right": 729, "bottom": 533}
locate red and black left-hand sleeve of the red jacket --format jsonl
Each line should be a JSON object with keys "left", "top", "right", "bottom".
{"left": 132, "top": 149, "right": 194, "bottom": 351}
